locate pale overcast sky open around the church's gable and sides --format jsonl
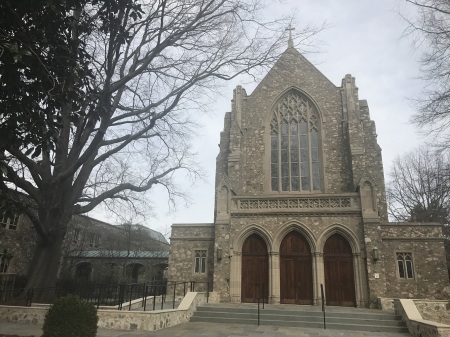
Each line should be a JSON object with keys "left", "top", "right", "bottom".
{"left": 88, "top": 0, "right": 424, "bottom": 235}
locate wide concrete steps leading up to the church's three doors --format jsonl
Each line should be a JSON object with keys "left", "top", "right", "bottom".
{"left": 191, "top": 304, "right": 408, "bottom": 333}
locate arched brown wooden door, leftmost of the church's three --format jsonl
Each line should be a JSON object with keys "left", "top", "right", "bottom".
{"left": 241, "top": 234, "right": 269, "bottom": 303}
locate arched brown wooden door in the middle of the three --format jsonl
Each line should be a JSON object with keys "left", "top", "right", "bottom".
{"left": 280, "top": 231, "right": 313, "bottom": 304}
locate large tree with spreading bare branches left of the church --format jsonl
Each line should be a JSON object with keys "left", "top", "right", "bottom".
{"left": 0, "top": 0, "right": 324, "bottom": 287}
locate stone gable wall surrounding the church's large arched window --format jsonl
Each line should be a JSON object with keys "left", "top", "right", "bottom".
{"left": 234, "top": 49, "right": 353, "bottom": 195}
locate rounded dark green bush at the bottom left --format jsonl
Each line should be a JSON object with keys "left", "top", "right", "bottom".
{"left": 42, "top": 295, "right": 98, "bottom": 337}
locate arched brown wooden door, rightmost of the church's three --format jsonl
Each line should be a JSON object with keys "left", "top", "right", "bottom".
{"left": 323, "top": 234, "right": 356, "bottom": 307}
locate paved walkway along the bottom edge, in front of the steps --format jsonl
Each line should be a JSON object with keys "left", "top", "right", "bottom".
{"left": 0, "top": 322, "right": 410, "bottom": 337}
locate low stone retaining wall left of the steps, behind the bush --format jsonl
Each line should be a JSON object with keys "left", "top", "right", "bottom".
{"left": 0, "top": 292, "right": 206, "bottom": 331}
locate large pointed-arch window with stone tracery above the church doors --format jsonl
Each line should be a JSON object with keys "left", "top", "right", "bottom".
{"left": 270, "top": 91, "right": 321, "bottom": 192}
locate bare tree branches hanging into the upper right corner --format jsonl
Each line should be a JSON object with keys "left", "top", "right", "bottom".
{"left": 405, "top": 0, "right": 450, "bottom": 146}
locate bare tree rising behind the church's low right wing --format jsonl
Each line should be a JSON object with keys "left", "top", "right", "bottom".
{"left": 387, "top": 148, "right": 450, "bottom": 220}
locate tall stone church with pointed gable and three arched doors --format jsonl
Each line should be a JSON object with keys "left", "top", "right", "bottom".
{"left": 168, "top": 40, "right": 449, "bottom": 307}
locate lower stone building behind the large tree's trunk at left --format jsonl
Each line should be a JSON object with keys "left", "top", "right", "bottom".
{"left": 0, "top": 213, "right": 169, "bottom": 288}
